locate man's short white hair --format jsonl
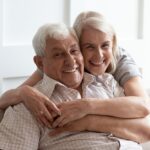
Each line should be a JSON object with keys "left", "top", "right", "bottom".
{"left": 32, "top": 23, "right": 78, "bottom": 56}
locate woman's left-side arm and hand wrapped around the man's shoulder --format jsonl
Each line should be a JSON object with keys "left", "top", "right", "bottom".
{"left": 0, "top": 71, "right": 60, "bottom": 127}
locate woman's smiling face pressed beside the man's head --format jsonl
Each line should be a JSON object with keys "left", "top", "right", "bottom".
{"left": 80, "top": 28, "right": 113, "bottom": 75}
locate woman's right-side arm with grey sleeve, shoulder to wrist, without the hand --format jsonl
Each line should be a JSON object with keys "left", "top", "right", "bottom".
{"left": 91, "top": 48, "right": 150, "bottom": 118}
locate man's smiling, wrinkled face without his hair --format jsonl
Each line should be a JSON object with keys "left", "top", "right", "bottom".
{"left": 43, "top": 36, "right": 84, "bottom": 88}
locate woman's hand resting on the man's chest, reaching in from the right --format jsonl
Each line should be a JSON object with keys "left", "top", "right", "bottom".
{"left": 52, "top": 100, "right": 89, "bottom": 128}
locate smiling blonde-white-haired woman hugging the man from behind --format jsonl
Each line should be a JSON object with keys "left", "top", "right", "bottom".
{"left": 0, "top": 12, "right": 149, "bottom": 143}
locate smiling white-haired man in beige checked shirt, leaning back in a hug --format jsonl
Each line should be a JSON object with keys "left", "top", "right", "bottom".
{"left": 0, "top": 24, "right": 149, "bottom": 150}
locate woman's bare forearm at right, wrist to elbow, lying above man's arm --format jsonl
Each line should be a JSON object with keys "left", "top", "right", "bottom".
{"left": 88, "top": 96, "right": 149, "bottom": 118}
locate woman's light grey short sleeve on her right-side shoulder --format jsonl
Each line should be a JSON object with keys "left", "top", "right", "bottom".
{"left": 113, "top": 48, "right": 142, "bottom": 86}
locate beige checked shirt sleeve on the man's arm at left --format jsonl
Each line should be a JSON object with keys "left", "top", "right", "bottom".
{"left": 0, "top": 104, "right": 40, "bottom": 150}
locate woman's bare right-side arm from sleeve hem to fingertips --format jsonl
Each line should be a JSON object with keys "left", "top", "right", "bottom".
{"left": 53, "top": 77, "right": 150, "bottom": 127}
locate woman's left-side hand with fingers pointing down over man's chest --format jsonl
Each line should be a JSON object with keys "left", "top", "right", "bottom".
{"left": 19, "top": 86, "right": 61, "bottom": 127}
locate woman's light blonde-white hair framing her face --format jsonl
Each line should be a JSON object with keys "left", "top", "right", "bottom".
{"left": 73, "top": 11, "right": 118, "bottom": 73}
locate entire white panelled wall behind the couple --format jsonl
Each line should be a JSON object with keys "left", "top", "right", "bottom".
{"left": 0, "top": 0, "right": 150, "bottom": 93}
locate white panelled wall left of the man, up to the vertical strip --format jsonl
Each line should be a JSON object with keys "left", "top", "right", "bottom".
{"left": 0, "top": 0, "right": 69, "bottom": 93}
